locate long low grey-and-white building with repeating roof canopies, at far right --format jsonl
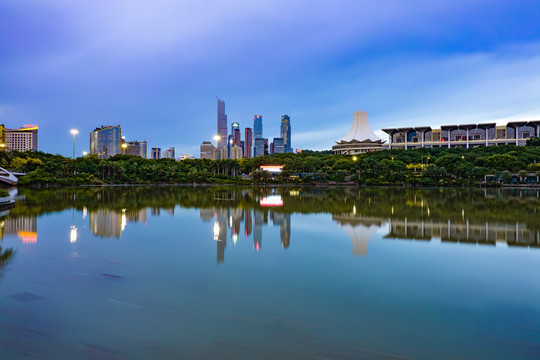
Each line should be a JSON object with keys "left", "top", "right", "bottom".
{"left": 382, "top": 120, "right": 540, "bottom": 149}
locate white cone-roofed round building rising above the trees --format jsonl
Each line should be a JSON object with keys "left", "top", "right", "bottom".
{"left": 332, "top": 111, "right": 382, "bottom": 154}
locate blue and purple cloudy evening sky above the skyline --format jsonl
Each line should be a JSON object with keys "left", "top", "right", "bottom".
{"left": 0, "top": 0, "right": 540, "bottom": 157}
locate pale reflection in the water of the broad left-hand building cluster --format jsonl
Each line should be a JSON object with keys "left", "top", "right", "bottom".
{"left": 89, "top": 208, "right": 147, "bottom": 238}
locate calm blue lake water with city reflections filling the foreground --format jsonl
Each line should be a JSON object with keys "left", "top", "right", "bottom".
{"left": 0, "top": 187, "right": 540, "bottom": 359}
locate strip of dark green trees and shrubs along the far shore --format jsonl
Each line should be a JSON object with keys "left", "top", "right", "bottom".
{"left": 0, "top": 139, "right": 540, "bottom": 186}
